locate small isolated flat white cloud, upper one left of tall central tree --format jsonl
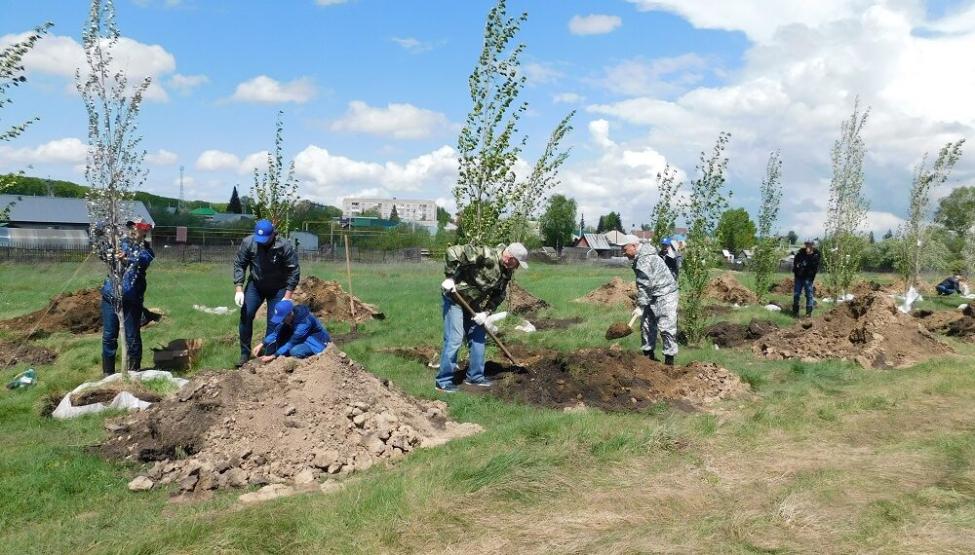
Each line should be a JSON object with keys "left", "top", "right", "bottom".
{"left": 331, "top": 100, "right": 451, "bottom": 139}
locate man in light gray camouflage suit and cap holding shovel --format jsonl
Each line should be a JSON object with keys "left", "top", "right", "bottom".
{"left": 623, "top": 235, "right": 678, "bottom": 366}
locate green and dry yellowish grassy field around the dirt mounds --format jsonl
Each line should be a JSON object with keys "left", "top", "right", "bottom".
{"left": 0, "top": 262, "right": 975, "bottom": 553}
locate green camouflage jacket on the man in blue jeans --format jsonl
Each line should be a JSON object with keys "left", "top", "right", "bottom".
{"left": 444, "top": 245, "right": 513, "bottom": 312}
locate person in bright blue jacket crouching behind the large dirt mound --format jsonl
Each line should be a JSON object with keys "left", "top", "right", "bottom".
{"left": 251, "top": 299, "right": 332, "bottom": 362}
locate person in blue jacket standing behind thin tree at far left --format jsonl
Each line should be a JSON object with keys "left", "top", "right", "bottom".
{"left": 102, "top": 220, "right": 155, "bottom": 376}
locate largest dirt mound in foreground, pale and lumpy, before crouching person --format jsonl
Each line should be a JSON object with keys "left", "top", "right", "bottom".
{"left": 100, "top": 349, "right": 480, "bottom": 491}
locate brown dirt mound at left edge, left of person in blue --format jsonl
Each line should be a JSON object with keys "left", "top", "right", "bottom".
{"left": 0, "top": 289, "right": 102, "bottom": 337}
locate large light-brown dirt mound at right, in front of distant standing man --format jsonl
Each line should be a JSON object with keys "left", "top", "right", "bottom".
{"left": 752, "top": 293, "right": 951, "bottom": 368}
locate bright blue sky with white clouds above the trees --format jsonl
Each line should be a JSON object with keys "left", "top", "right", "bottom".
{"left": 0, "top": 0, "right": 975, "bottom": 237}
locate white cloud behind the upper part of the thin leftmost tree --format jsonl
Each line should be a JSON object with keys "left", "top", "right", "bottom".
{"left": 0, "top": 33, "right": 176, "bottom": 102}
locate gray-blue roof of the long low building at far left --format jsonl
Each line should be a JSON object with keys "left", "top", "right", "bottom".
{"left": 0, "top": 195, "right": 155, "bottom": 232}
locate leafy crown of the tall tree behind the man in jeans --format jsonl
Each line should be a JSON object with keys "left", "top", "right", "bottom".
{"left": 454, "top": 0, "right": 575, "bottom": 243}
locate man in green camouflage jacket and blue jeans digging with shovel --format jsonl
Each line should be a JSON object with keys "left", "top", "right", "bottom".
{"left": 436, "top": 243, "right": 528, "bottom": 393}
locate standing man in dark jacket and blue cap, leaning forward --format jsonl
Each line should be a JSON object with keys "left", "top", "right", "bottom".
{"left": 234, "top": 220, "right": 301, "bottom": 367}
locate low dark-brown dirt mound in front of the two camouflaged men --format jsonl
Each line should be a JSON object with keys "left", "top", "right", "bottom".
{"left": 491, "top": 349, "right": 748, "bottom": 411}
